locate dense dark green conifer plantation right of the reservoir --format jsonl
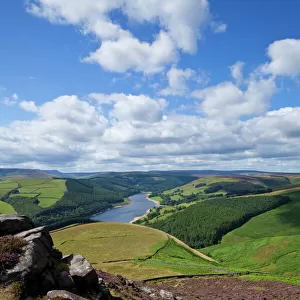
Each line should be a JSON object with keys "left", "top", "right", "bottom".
{"left": 148, "top": 196, "right": 290, "bottom": 249}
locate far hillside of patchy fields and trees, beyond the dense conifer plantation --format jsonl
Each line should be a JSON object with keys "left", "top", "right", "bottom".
{"left": 141, "top": 172, "right": 300, "bottom": 234}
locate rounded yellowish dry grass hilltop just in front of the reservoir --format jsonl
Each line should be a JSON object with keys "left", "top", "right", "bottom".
{"left": 51, "top": 223, "right": 168, "bottom": 264}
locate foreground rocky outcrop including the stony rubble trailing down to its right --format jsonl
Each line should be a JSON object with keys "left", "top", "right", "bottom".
{"left": 0, "top": 215, "right": 180, "bottom": 300}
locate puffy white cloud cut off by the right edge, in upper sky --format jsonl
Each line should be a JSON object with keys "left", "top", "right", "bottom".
{"left": 261, "top": 39, "right": 300, "bottom": 77}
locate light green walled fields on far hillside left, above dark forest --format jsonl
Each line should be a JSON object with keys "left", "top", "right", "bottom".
{"left": 10, "top": 178, "right": 66, "bottom": 208}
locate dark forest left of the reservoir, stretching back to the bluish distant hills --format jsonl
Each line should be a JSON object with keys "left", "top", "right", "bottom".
{"left": 1, "top": 172, "right": 194, "bottom": 229}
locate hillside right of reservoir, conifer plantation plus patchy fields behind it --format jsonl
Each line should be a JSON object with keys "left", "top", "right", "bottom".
{"left": 135, "top": 174, "right": 300, "bottom": 248}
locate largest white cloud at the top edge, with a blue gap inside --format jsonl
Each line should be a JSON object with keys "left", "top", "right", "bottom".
{"left": 27, "top": 0, "right": 218, "bottom": 73}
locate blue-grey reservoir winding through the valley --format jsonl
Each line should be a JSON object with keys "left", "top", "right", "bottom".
{"left": 91, "top": 194, "right": 156, "bottom": 223}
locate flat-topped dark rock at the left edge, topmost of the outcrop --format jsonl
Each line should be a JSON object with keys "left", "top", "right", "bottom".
{"left": 0, "top": 215, "right": 34, "bottom": 236}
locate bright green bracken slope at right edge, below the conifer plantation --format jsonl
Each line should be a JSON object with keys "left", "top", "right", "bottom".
{"left": 202, "top": 192, "right": 300, "bottom": 276}
